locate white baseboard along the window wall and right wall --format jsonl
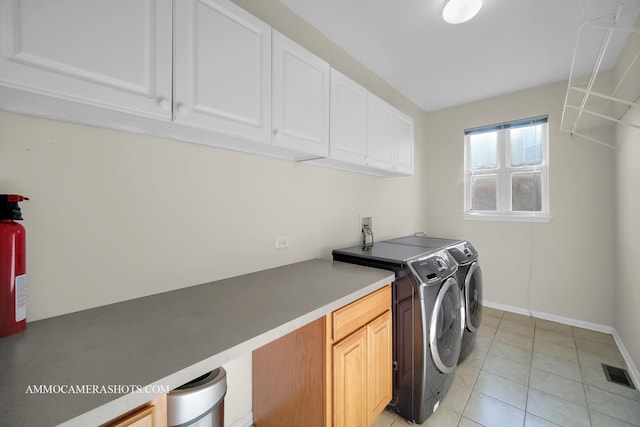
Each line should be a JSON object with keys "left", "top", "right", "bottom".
{"left": 482, "top": 301, "right": 640, "bottom": 387}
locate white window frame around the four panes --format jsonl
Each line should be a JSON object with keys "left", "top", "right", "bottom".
{"left": 463, "top": 116, "right": 551, "bottom": 222}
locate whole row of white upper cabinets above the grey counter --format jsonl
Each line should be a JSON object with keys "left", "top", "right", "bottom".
{"left": 0, "top": 0, "right": 414, "bottom": 176}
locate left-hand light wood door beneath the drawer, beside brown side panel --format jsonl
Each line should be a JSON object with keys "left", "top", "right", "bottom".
{"left": 333, "top": 328, "right": 369, "bottom": 427}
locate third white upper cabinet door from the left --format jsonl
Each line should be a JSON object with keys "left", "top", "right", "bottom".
{"left": 272, "top": 30, "right": 330, "bottom": 157}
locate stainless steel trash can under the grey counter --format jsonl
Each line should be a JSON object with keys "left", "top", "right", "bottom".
{"left": 167, "top": 368, "right": 227, "bottom": 427}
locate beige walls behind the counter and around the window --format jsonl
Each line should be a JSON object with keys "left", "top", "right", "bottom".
{"left": 0, "top": 0, "right": 640, "bottom": 425}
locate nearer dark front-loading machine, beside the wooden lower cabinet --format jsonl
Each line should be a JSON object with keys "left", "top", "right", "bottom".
{"left": 333, "top": 242, "right": 464, "bottom": 424}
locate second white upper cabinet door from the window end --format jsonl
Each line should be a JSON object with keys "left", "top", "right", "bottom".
{"left": 367, "top": 93, "right": 396, "bottom": 169}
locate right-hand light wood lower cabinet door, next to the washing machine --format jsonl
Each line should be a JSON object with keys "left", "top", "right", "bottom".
{"left": 367, "top": 311, "right": 393, "bottom": 425}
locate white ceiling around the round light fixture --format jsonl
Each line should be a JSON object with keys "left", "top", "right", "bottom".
{"left": 281, "top": 0, "right": 632, "bottom": 111}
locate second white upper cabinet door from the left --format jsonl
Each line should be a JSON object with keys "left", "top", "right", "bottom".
{"left": 174, "top": 0, "right": 271, "bottom": 142}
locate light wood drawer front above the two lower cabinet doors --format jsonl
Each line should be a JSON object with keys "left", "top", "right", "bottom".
{"left": 332, "top": 285, "right": 391, "bottom": 342}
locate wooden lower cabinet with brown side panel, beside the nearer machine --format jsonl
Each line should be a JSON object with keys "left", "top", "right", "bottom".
{"left": 253, "top": 285, "right": 393, "bottom": 427}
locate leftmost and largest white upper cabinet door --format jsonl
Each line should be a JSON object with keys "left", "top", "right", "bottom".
{"left": 0, "top": 0, "right": 172, "bottom": 119}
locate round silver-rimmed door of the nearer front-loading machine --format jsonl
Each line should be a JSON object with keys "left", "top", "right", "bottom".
{"left": 429, "top": 278, "right": 464, "bottom": 374}
